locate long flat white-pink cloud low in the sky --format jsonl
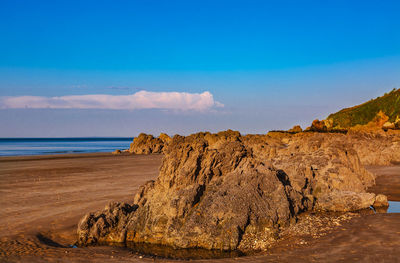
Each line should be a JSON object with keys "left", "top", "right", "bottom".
{"left": 0, "top": 90, "right": 224, "bottom": 111}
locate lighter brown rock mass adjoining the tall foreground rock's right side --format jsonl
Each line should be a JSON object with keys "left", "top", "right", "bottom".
{"left": 246, "top": 133, "right": 375, "bottom": 211}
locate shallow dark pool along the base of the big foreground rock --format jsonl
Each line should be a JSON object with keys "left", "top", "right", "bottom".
{"left": 104, "top": 242, "right": 246, "bottom": 260}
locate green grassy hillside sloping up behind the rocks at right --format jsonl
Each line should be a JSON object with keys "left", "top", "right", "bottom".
{"left": 328, "top": 89, "right": 400, "bottom": 128}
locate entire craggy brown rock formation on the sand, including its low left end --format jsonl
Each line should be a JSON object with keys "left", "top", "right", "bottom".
{"left": 78, "top": 131, "right": 388, "bottom": 253}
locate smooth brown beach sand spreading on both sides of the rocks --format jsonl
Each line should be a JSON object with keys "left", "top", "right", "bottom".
{"left": 0, "top": 154, "right": 400, "bottom": 262}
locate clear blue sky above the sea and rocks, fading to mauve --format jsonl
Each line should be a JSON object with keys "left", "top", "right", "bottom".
{"left": 0, "top": 0, "right": 400, "bottom": 137}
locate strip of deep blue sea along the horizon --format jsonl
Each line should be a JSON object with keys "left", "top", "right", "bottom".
{"left": 0, "top": 138, "right": 133, "bottom": 156}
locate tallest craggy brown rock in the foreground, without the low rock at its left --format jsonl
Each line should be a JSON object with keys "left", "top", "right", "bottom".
{"left": 123, "top": 134, "right": 306, "bottom": 252}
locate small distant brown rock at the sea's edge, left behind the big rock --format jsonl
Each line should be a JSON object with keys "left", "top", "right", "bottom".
{"left": 129, "top": 133, "right": 171, "bottom": 154}
